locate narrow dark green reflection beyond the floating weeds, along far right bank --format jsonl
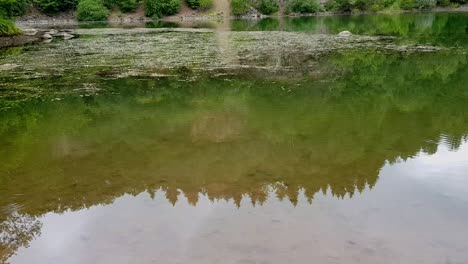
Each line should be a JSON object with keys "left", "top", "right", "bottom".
{"left": 232, "top": 13, "right": 468, "bottom": 47}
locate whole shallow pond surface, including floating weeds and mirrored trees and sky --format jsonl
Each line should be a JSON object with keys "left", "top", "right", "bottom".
{"left": 0, "top": 11, "right": 468, "bottom": 264}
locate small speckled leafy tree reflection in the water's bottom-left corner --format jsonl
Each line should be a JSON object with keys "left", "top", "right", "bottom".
{"left": 0, "top": 213, "right": 42, "bottom": 263}
